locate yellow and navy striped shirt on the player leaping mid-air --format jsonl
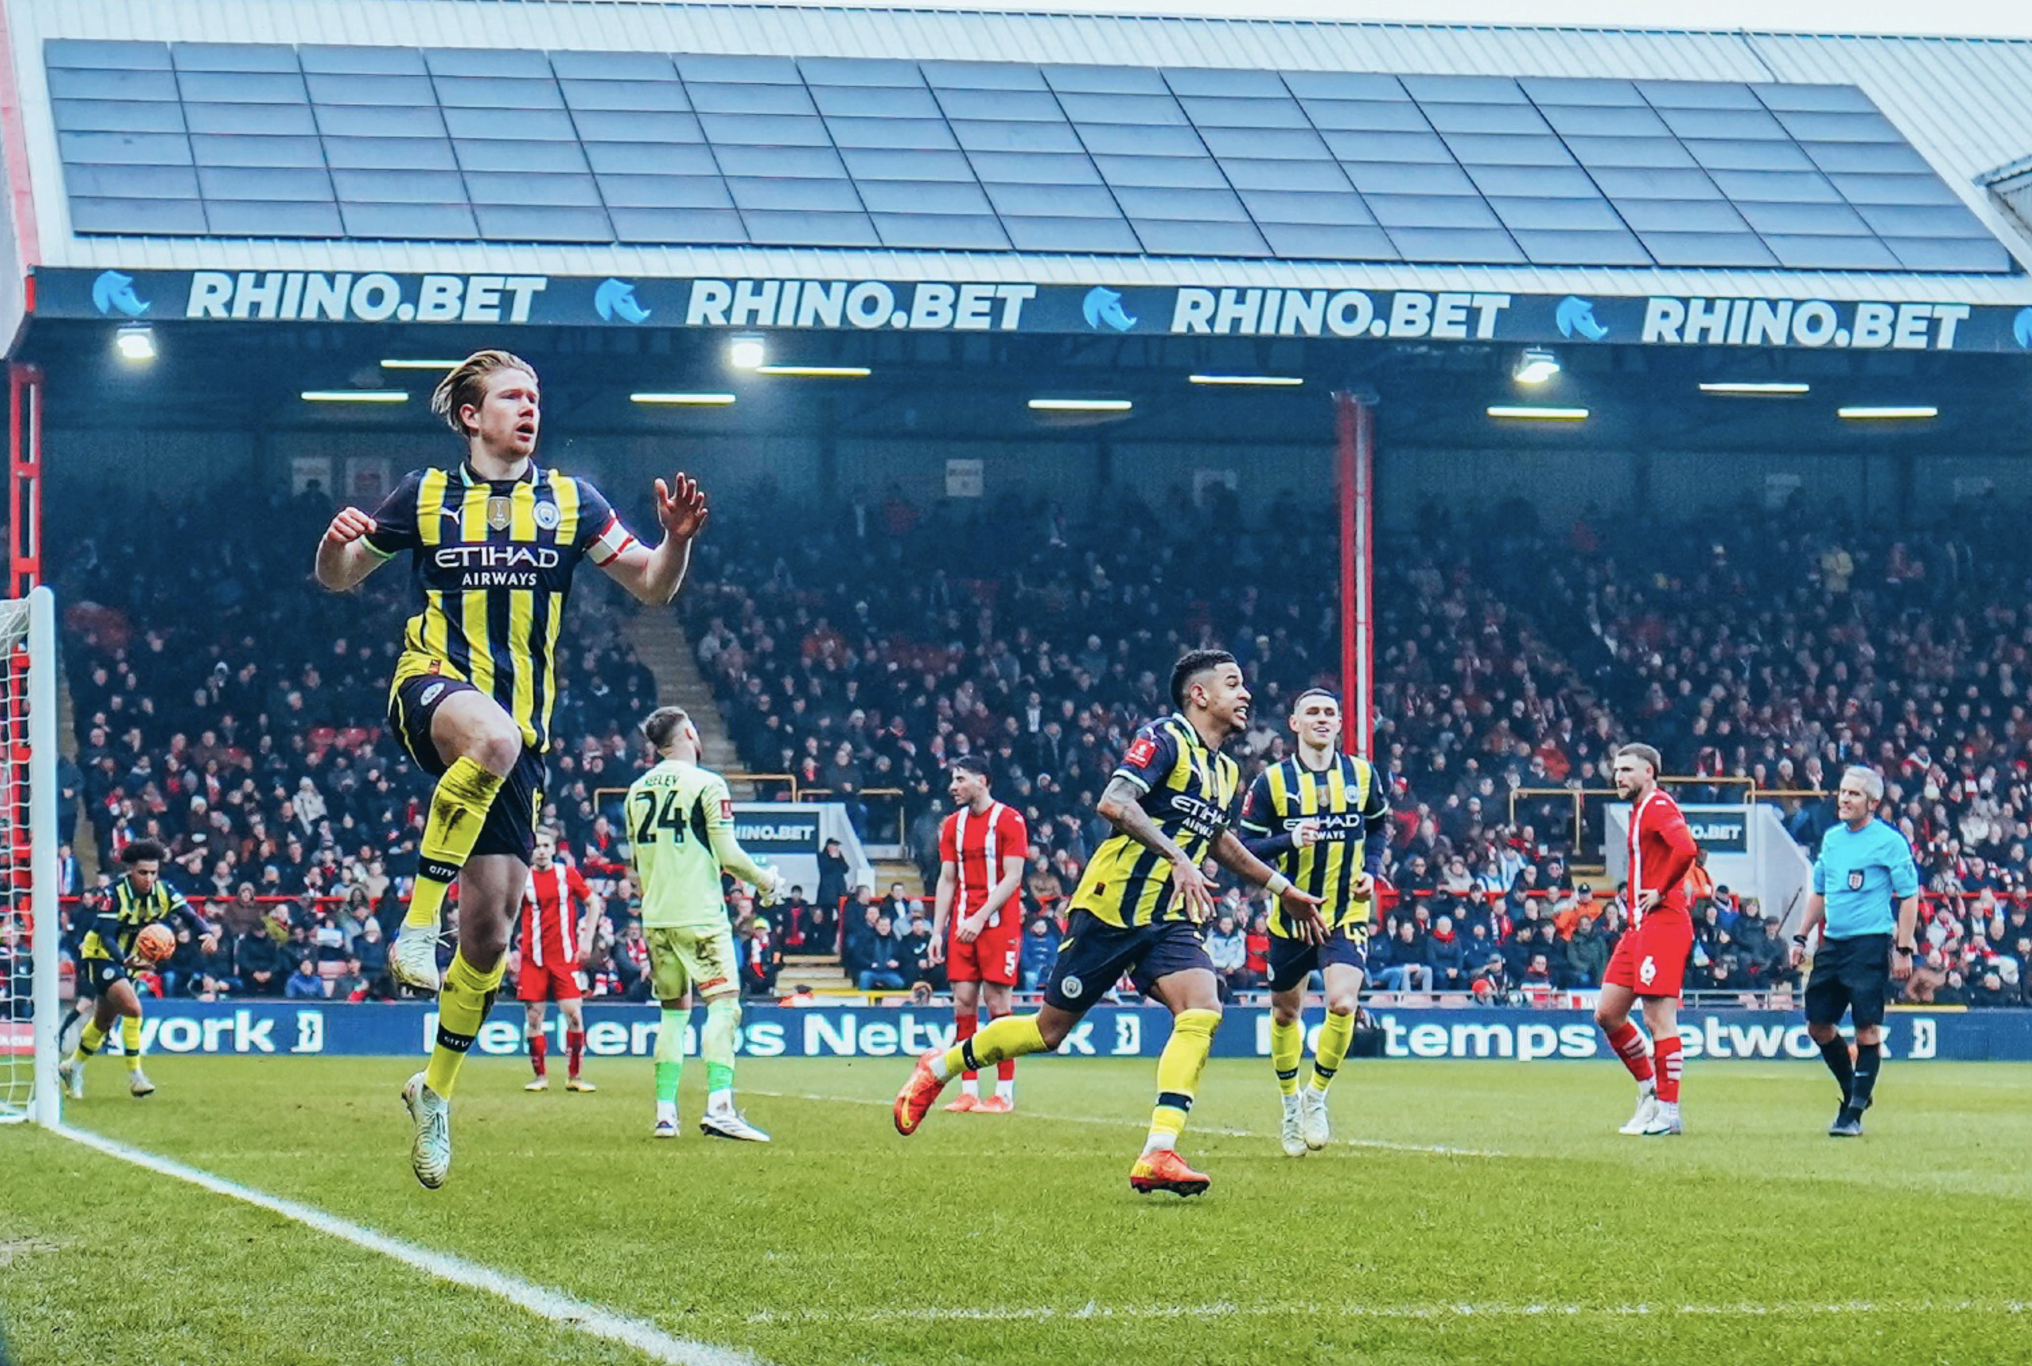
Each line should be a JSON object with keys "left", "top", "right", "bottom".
{"left": 368, "top": 461, "right": 634, "bottom": 750}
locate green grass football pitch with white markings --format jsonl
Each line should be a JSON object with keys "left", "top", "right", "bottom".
{"left": 0, "top": 1057, "right": 2032, "bottom": 1366}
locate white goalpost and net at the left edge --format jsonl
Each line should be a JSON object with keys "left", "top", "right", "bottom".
{"left": 0, "top": 587, "right": 59, "bottom": 1124}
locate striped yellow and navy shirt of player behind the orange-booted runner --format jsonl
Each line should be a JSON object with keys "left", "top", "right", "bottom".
{"left": 1242, "top": 754, "right": 1390, "bottom": 939}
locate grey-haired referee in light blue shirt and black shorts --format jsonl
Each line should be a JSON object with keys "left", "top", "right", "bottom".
{"left": 1792, "top": 768, "right": 1918, "bottom": 1138}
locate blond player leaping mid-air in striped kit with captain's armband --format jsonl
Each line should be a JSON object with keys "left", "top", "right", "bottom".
{"left": 317, "top": 352, "right": 707, "bottom": 1189}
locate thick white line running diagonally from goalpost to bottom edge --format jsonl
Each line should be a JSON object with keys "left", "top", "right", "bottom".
{"left": 53, "top": 1124, "right": 760, "bottom": 1366}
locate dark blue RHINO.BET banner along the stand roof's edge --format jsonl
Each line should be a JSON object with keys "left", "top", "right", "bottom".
{"left": 30, "top": 268, "right": 2032, "bottom": 352}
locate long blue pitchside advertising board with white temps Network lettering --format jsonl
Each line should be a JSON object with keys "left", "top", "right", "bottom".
{"left": 71, "top": 1000, "right": 2032, "bottom": 1063}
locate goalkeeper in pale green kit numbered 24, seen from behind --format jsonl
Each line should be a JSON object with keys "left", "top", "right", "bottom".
{"left": 626, "top": 707, "right": 784, "bottom": 1142}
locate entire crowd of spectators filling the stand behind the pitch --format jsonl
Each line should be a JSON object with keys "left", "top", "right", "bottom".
{"left": 27, "top": 463, "right": 2032, "bottom": 1000}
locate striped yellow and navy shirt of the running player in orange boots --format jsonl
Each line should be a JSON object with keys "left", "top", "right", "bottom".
{"left": 1073, "top": 713, "right": 1242, "bottom": 929}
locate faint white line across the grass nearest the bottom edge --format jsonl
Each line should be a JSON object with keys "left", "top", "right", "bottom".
{"left": 748, "top": 1299, "right": 2032, "bottom": 1325}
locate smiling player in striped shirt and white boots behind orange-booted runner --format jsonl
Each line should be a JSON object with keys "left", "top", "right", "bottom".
{"left": 1242, "top": 687, "right": 1390, "bottom": 1157}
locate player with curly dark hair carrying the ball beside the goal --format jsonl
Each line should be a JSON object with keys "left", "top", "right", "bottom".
{"left": 57, "top": 840, "right": 219, "bottom": 1100}
